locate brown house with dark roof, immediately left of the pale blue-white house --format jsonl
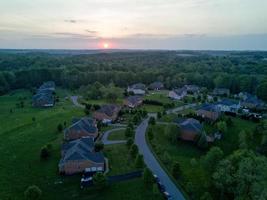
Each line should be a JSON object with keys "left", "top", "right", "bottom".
{"left": 196, "top": 104, "right": 221, "bottom": 121}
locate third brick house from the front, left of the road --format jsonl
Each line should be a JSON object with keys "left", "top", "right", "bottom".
{"left": 94, "top": 104, "right": 121, "bottom": 123}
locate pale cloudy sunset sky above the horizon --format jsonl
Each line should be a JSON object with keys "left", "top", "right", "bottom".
{"left": 0, "top": 0, "right": 267, "bottom": 50}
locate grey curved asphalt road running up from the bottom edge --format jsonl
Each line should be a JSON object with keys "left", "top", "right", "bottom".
{"left": 135, "top": 118, "right": 185, "bottom": 200}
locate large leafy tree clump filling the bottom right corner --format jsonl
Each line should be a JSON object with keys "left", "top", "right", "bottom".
{"left": 212, "top": 150, "right": 267, "bottom": 200}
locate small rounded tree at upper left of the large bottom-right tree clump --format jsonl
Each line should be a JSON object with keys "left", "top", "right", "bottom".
{"left": 201, "top": 147, "right": 223, "bottom": 173}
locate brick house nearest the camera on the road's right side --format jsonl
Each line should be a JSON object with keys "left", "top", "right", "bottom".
{"left": 179, "top": 118, "right": 205, "bottom": 142}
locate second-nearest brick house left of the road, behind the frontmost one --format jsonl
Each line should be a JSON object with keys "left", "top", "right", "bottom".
{"left": 64, "top": 117, "right": 98, "bottom": 140}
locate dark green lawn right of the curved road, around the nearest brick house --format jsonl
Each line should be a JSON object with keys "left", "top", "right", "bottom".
{"left": 150, "top": 118, "right": 258, "bottom": 199}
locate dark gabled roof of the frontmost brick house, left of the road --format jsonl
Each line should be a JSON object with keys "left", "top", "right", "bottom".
{"left": 60, "top": 137, "right": 104, "bottom": 164}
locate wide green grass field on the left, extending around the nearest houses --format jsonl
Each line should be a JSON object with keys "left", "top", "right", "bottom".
{"left": 0, "top": 90, "right": 162, "bottom": 200}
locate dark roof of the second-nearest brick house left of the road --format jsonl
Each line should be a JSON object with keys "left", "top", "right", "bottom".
{"left": 64, "top": 117, "right": 97, "bottom": 138}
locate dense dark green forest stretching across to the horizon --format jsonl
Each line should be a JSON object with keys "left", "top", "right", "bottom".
{"left": 0, "top": 50, "right": 267, "bottom": 100}
